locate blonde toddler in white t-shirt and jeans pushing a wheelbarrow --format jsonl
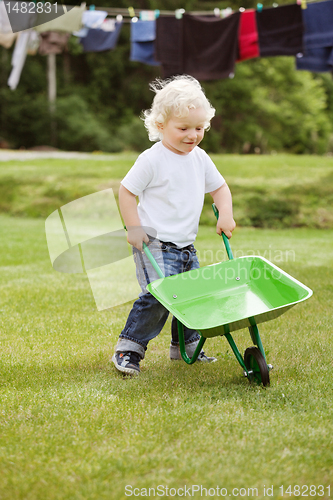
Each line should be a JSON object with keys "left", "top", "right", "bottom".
{"left": 112, "top": 75, "right": 236, "bottom": 375}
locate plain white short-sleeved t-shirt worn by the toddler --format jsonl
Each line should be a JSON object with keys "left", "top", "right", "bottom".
{"left": 121, "top": 142, "right": 225, "bottom": 248}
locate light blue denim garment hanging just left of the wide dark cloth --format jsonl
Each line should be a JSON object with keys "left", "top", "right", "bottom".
{"left": 130, "top": 20, "right": 159, "bottom": 66}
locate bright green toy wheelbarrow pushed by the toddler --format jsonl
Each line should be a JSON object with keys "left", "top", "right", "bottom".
{"left": 143, "top": 204, "right": 312, "bottom": 386}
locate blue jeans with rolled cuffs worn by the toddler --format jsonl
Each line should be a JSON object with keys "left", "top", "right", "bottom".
{"left": 116, "top": 239, "right": 200, "bottom": 359}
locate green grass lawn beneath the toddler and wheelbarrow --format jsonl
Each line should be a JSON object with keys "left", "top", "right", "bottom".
{"left": 0, "top": 212, "right": 333, "bottom": 500}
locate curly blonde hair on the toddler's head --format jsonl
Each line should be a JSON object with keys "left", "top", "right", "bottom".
{"left": 142, "top": 75, "right": 215, "bottom": 141}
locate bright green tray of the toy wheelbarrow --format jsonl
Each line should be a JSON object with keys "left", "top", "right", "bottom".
{"left": 147, "top": 256, "right": 312, "bottom": 338}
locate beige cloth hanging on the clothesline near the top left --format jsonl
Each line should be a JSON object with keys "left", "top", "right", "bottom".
{"left": 36, "top": 4, "right": 86, "bottom": 33}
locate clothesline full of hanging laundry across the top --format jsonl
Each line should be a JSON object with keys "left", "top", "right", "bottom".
{"left": 0, "top": 0, "right": 333, "bottom": 89}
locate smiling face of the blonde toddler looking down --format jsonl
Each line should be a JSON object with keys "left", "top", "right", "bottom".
{"left": 159, "top": 108, "right": 206, "bottom": 155}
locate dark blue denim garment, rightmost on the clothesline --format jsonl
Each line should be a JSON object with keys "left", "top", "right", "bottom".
{"left": 296, "top": 0, "right": 333, "bottom": 73}
